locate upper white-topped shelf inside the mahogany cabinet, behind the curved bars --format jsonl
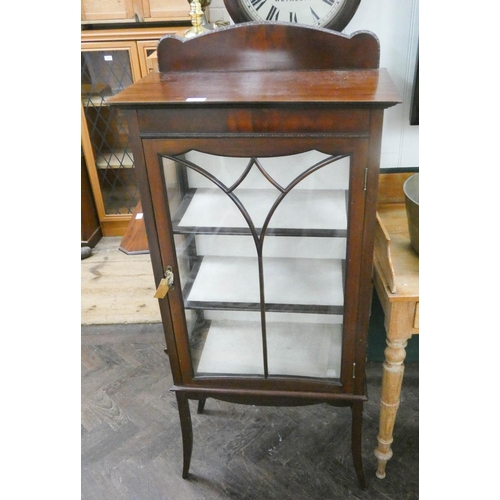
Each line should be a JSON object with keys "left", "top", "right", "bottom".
{"left": 172, "top": 188, "right": 347, "bottom": 238}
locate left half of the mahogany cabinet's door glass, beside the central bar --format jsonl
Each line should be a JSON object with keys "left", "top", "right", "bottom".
{"left": 163, "top": 152, "right": 264, "bottom": 376}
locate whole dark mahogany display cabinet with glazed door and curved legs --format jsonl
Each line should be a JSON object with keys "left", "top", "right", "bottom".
{"left": 108, "top": 23, "right": 400, "bottom": 487}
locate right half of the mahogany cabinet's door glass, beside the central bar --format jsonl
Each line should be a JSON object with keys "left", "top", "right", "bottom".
{"left": 261, "top": 155, "right": 349, "bottom": 379}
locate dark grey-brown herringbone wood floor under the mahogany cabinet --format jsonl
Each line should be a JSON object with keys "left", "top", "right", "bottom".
{"left": 81, "top": 323, "right": 419, "bottom": 500}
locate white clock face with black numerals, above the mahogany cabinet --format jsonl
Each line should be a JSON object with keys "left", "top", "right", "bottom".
{"left": 224, "top": 0, "right": 360, "bottom": 30}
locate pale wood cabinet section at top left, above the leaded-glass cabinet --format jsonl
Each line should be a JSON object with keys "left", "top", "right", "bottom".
{"left": 81, "top": 0, "right": 190, "bottom": 23}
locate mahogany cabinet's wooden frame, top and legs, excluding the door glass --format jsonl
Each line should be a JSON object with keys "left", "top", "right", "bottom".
{"left": 108, "top": 23, "right": 400, "bottom": 487}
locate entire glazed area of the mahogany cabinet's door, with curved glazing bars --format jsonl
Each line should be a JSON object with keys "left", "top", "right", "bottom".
{"left": 163, "top": 151, "right": 349, "bottom": 379}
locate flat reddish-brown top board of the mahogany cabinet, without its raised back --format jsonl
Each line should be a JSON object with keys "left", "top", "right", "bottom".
{"left": 107, "top": 69, "right": 401, "bottom": 108}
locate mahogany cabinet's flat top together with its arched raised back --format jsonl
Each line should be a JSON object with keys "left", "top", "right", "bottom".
{"left": 108, "top": 23, "right": 401, "bottom": 108}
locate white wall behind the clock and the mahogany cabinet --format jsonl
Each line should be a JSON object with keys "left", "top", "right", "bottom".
{"left": 205, "top": 0, "right": 419, "bottom": 168}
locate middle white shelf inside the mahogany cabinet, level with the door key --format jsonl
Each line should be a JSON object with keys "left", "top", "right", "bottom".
{"left": 183, "top": 256, "right": 344, "bottom": 315}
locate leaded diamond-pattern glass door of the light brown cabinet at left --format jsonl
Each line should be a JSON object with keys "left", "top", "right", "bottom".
{"left": 81, "top": 50, "right": 139, "bottom": 215}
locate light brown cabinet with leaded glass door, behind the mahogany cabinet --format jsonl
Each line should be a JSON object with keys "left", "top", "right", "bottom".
{"left": 81, "top": 27, "right": 187, "bottom": 236}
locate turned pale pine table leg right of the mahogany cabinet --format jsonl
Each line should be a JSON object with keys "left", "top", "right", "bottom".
{"left": 375, "top": 339, "right": 407, "bottom": 479}
